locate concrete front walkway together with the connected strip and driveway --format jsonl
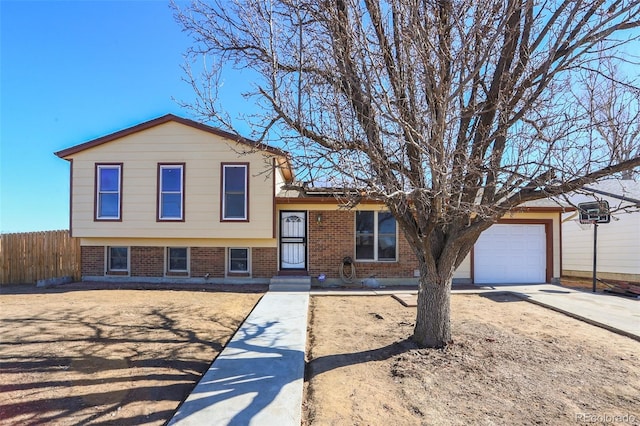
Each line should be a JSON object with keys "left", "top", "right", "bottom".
{"left": 169, "top": 284, "right": 640, "bottom": 426}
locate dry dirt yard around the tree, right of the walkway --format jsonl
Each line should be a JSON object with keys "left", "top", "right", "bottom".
{"left": 303, "top": 295, "right": 640, "bottom": 425}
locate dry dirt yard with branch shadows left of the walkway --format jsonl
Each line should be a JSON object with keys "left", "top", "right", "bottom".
{"left": 0, "top": 286, "right": 261, "bottom": 425}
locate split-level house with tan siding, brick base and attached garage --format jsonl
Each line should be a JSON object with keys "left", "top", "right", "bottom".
{"left": 56, "top": 115, "right": 562, "bottom": 285}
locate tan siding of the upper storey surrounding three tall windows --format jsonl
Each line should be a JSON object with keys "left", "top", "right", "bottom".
{"left": 72, "top": 122, "right": 273, "bottom": 239}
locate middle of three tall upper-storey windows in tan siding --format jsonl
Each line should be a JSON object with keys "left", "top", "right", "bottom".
{"left": 158, "top": 163, "right": 184, "bottom": 221}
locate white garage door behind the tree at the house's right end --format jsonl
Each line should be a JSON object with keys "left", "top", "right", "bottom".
{"left": 473, "top": 224, "right": 546, "bottom": 284}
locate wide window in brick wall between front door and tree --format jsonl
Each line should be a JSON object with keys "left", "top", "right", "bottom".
{"left": 356, "top": 211, "right": 398, "bottom": 261}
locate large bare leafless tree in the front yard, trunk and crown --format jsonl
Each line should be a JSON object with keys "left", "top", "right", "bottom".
{"left": 175, "top": 0, "right": 640, "bottom": 347}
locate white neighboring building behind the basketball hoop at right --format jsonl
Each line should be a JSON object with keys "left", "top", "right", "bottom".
{"left": 562, "top": 179, "right": 640, "bottom": 282}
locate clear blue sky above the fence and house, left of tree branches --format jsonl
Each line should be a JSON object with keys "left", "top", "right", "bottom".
{"left": 0, "top": 0, "right": 252, "bottom": 232}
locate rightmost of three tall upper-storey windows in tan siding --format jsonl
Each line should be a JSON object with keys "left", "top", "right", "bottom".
{"left": 220, "top": 163, "right": 249, "bottom": 221}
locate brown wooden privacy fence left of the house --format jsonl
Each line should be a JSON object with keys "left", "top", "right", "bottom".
{"left": 0, "top": 231, "right": 80, "bottom": 284}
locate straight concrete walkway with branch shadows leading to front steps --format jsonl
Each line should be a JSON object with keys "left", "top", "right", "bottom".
{"left": 169, "top": 291, "right": 309, "bottom": 426}
